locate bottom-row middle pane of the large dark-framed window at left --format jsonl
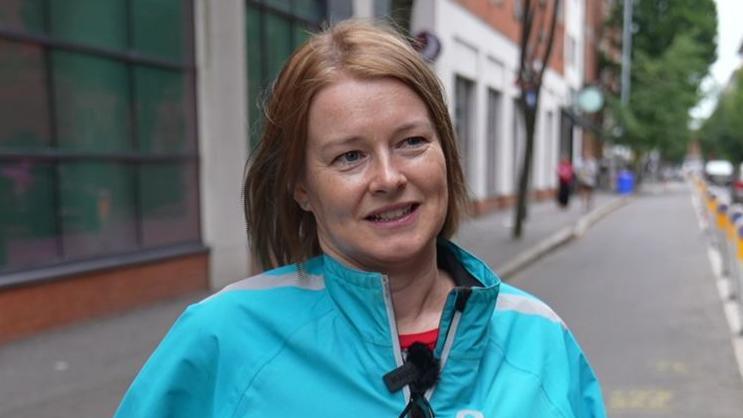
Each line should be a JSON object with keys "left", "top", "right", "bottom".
{"left": 59, "top": 162, "right": 137, "bottom": 259}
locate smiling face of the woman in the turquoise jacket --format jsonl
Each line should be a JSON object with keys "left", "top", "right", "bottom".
{"left": 294, "top": 77, "right": 448, "bottom": 271}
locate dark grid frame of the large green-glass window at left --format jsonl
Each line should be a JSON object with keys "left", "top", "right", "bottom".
{"left": 0, "top": 0, "right": 203, "bottom": 288}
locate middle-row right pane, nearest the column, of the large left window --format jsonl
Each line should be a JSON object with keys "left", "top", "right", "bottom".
{"left": 134, "top": 67, "right": 196, "bottom": 152}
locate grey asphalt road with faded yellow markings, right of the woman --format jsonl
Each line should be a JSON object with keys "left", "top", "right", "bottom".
{"left": 512, "top": 189, "right": 743, "bottom": 418}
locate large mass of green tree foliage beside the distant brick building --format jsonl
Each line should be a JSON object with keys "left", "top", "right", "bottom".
{"left": 609, "top": 0, "right": 717, "bottom": 161}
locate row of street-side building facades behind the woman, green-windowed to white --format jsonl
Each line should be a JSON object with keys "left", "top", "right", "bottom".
{"left": 0, "top": 0, "right": 590, "bottom": 343}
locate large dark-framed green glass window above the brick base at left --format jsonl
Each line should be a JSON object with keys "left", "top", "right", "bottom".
{"left": 0, "top": 0, "right": 200, "bottom": 280}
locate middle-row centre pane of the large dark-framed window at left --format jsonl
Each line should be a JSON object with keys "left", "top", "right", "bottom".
{"left": 52, "top": 51, "right": 131, "bottom": 152}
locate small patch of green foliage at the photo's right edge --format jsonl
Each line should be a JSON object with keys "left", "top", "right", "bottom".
{"left": 699, "top": 69, "right": 743, "bottom": 162}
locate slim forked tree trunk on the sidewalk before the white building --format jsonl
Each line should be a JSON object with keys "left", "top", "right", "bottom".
{"left": 513, "top": 0, "right": 560, "bottom": 238}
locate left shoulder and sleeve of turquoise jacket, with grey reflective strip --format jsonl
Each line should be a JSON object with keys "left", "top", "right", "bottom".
{"left": 116, "top": 260, "right": 328, "bottom": 418}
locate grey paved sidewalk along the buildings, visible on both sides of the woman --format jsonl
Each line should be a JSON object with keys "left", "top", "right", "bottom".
{"left": 0, "top": 193, "right": 626, "bottom": 418}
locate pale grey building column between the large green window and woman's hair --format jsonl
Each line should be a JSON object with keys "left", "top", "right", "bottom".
{"left": 195, "top": 0, "right": 250, "bottom": 289}
